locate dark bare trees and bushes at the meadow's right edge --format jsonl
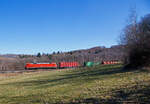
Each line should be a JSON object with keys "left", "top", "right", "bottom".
{"left": 120, "top": 12, "right": 150, "bottom": 68}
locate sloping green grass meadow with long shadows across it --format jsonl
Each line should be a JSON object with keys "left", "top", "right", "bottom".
{"left": 0, "top": 65, "right": 150, "bottom": 104}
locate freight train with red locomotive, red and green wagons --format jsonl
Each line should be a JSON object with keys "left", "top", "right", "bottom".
{"left": 25, "top": 61, "right": 120, "bottom": 69}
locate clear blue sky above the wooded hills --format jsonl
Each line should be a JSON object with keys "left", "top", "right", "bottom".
{"left": 0, "top": 0, "right": 150, "bottom": 54}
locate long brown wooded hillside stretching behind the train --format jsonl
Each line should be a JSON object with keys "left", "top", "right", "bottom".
{"left": 0, "top": 45, "right": 124, "bottom": 71}
